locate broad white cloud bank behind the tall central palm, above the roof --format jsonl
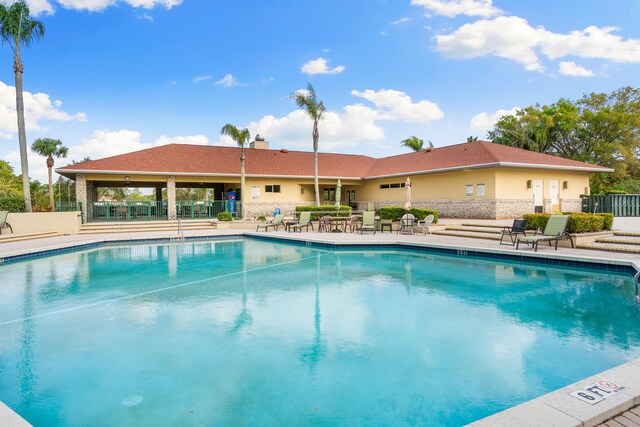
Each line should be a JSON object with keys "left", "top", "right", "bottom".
{"left": 242, "top": 90, "right": 443, "bottom": 150}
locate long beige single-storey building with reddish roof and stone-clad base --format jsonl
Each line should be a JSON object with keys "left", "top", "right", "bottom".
{"left": 56, "top": 141, "right": 612, "bottom": 219}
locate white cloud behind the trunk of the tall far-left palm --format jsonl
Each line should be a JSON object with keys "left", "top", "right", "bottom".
{"left": 0, "top": 81, "right": 87, "bottom": 138}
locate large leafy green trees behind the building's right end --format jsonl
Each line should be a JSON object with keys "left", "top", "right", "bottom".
{"left": 488, "top": 87, "right": 640, "bottom": 194}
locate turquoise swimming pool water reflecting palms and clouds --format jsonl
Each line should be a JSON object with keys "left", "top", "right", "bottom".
{"left": 0, "top": 240, "right": 640, "bottom": 426}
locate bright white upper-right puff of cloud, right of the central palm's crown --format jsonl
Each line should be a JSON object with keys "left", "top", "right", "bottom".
{"left": 351, "top": 89, "right": 444, "bottom": 122}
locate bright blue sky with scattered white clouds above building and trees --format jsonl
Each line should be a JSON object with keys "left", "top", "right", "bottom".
{"left": 0, "top": 0, "right": 640, "bottom": 181}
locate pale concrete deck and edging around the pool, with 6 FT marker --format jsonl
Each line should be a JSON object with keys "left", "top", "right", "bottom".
{"left": 0, "top": 226, "right": 640, "bottom": 427}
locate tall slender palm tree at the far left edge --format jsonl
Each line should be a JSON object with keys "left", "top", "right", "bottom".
{"left": 0, "top": 0, "right": 44, "bottom": 212}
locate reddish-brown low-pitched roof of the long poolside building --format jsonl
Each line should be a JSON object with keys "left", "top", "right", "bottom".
{"left": 56, "top": 141, "right": 611, "bottom": 179}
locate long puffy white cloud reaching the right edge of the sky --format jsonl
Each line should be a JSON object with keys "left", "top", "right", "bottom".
{"left": 435, "top": 16, "right": 640, "bottom": 71}
